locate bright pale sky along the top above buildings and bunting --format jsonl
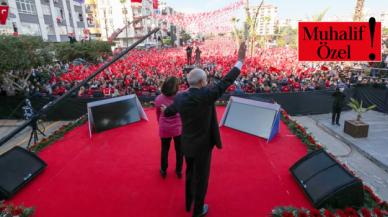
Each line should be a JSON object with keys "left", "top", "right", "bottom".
{"left": 162, "top": 0, "right": 388, "bottom": 26}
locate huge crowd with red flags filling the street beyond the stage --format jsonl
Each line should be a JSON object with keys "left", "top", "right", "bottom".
{"left": 1, "top": 37, "right": 388, "bottom": 98}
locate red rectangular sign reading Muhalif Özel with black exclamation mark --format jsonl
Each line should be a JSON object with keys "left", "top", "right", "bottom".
{"left": 298, "top": 17, "right": 381, "bottom": 62}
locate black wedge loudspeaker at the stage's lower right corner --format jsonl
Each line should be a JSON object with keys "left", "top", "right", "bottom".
{"left": 290, "top": 149, "right": 364, "bottom": 209}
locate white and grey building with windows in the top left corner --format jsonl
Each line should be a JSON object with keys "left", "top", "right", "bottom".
{"left": 0, "top": 0, "right": 88, "bottom": 42}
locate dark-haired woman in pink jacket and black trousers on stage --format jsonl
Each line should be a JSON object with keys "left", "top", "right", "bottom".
{"left": 155, "top": 76, "right": 183, "bottom": 178}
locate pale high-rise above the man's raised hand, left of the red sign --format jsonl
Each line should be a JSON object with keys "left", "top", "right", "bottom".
{"left": 249, "top": 5, "right": 278, "bottom": 35}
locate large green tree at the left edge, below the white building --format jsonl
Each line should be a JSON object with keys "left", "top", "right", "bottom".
{"left": 0, "top": 35, "right": 54, "bottom": 92}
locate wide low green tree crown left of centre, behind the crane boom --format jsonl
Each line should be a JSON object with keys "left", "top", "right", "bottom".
{"left": 55, "top": 41, "right": 114, "bottom": 63}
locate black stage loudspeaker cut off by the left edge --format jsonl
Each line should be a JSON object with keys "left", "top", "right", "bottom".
{"left": 0, "top": 146, "right": 47, "bottom": 201}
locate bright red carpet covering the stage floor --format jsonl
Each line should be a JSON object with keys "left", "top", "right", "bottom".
{"left": 9, "top": 107, "right": 312, "bottom": 217}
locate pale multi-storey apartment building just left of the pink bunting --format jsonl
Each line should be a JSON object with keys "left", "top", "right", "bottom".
{"left": 91, "top": 0, "right": 173, "bottom": 47}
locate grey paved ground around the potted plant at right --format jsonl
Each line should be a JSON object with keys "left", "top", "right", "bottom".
{"left": 311, "top": 110, "right": 388, "bottom": 172}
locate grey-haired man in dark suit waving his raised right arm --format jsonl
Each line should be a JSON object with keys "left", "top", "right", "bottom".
{"left": 161, "top": 42, "right": 246, "bottom": 217}
